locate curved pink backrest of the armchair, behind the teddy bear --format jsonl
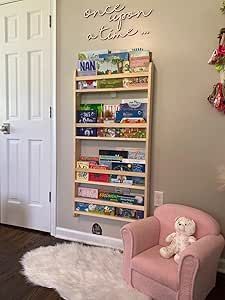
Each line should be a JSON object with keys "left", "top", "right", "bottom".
{"left": 154, "top": 204, "right": 220, "bottom": 245}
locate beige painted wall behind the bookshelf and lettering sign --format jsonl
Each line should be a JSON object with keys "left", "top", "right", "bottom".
{"left": 57, "top": 0, "right": 225, "bottom": 244}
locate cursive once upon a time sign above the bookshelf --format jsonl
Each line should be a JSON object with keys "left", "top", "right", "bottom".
{"left": 84, "top": 4, "right": 153, "bottom": 41}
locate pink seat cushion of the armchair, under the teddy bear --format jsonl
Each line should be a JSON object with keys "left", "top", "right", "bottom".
{"left": 131, "top": 245, "right": 178, "bottom": 291}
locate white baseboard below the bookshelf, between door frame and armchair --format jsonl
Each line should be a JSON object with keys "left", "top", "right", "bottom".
{"left": 55, "top": 227, "right": 123, "bottom": 250}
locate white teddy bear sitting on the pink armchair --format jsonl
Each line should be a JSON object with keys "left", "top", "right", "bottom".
{"left": 160, "top": 217, "right": 196, "bottom": 263}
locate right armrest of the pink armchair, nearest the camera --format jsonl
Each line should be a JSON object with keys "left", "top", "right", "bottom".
{"left": 178, "top": 235, "right": 225, "bottom": 300}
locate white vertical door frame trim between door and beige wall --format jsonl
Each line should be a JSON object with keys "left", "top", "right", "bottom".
{"left": 0, "top": 0, "right": 57, "bottom": 236}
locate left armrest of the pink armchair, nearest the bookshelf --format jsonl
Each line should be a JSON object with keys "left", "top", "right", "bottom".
{"left": 121, "top": 217, "right": 160, "bottom": 258}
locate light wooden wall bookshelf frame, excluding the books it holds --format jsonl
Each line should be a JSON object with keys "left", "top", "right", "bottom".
{"left": 73, "top": 63, "right": 153, "bottom": 222}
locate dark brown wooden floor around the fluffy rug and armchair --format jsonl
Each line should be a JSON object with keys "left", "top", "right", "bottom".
{"left": 0, "top": 225, "right": 225, "bottom": 300}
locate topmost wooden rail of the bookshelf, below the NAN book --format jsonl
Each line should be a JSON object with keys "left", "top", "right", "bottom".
{"left": 75, "top": 72, "right": 149, "bottom": 81}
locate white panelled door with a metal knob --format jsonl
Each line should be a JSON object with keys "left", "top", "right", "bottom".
{"left": 0, "top": 0, "right": 51, "bottom": 232}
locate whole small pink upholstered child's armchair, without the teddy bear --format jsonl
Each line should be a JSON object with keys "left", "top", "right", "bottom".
{"left": 121, "top": 204, "right": 224, "bottom": 300}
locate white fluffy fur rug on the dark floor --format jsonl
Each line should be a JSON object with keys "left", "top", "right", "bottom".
{"left": 21, "top": 243, "right": 147, "bottom": 300}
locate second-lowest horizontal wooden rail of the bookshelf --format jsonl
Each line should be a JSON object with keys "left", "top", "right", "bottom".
{"left": 74, "top": 197, "right": 145, "bottom": 211}
